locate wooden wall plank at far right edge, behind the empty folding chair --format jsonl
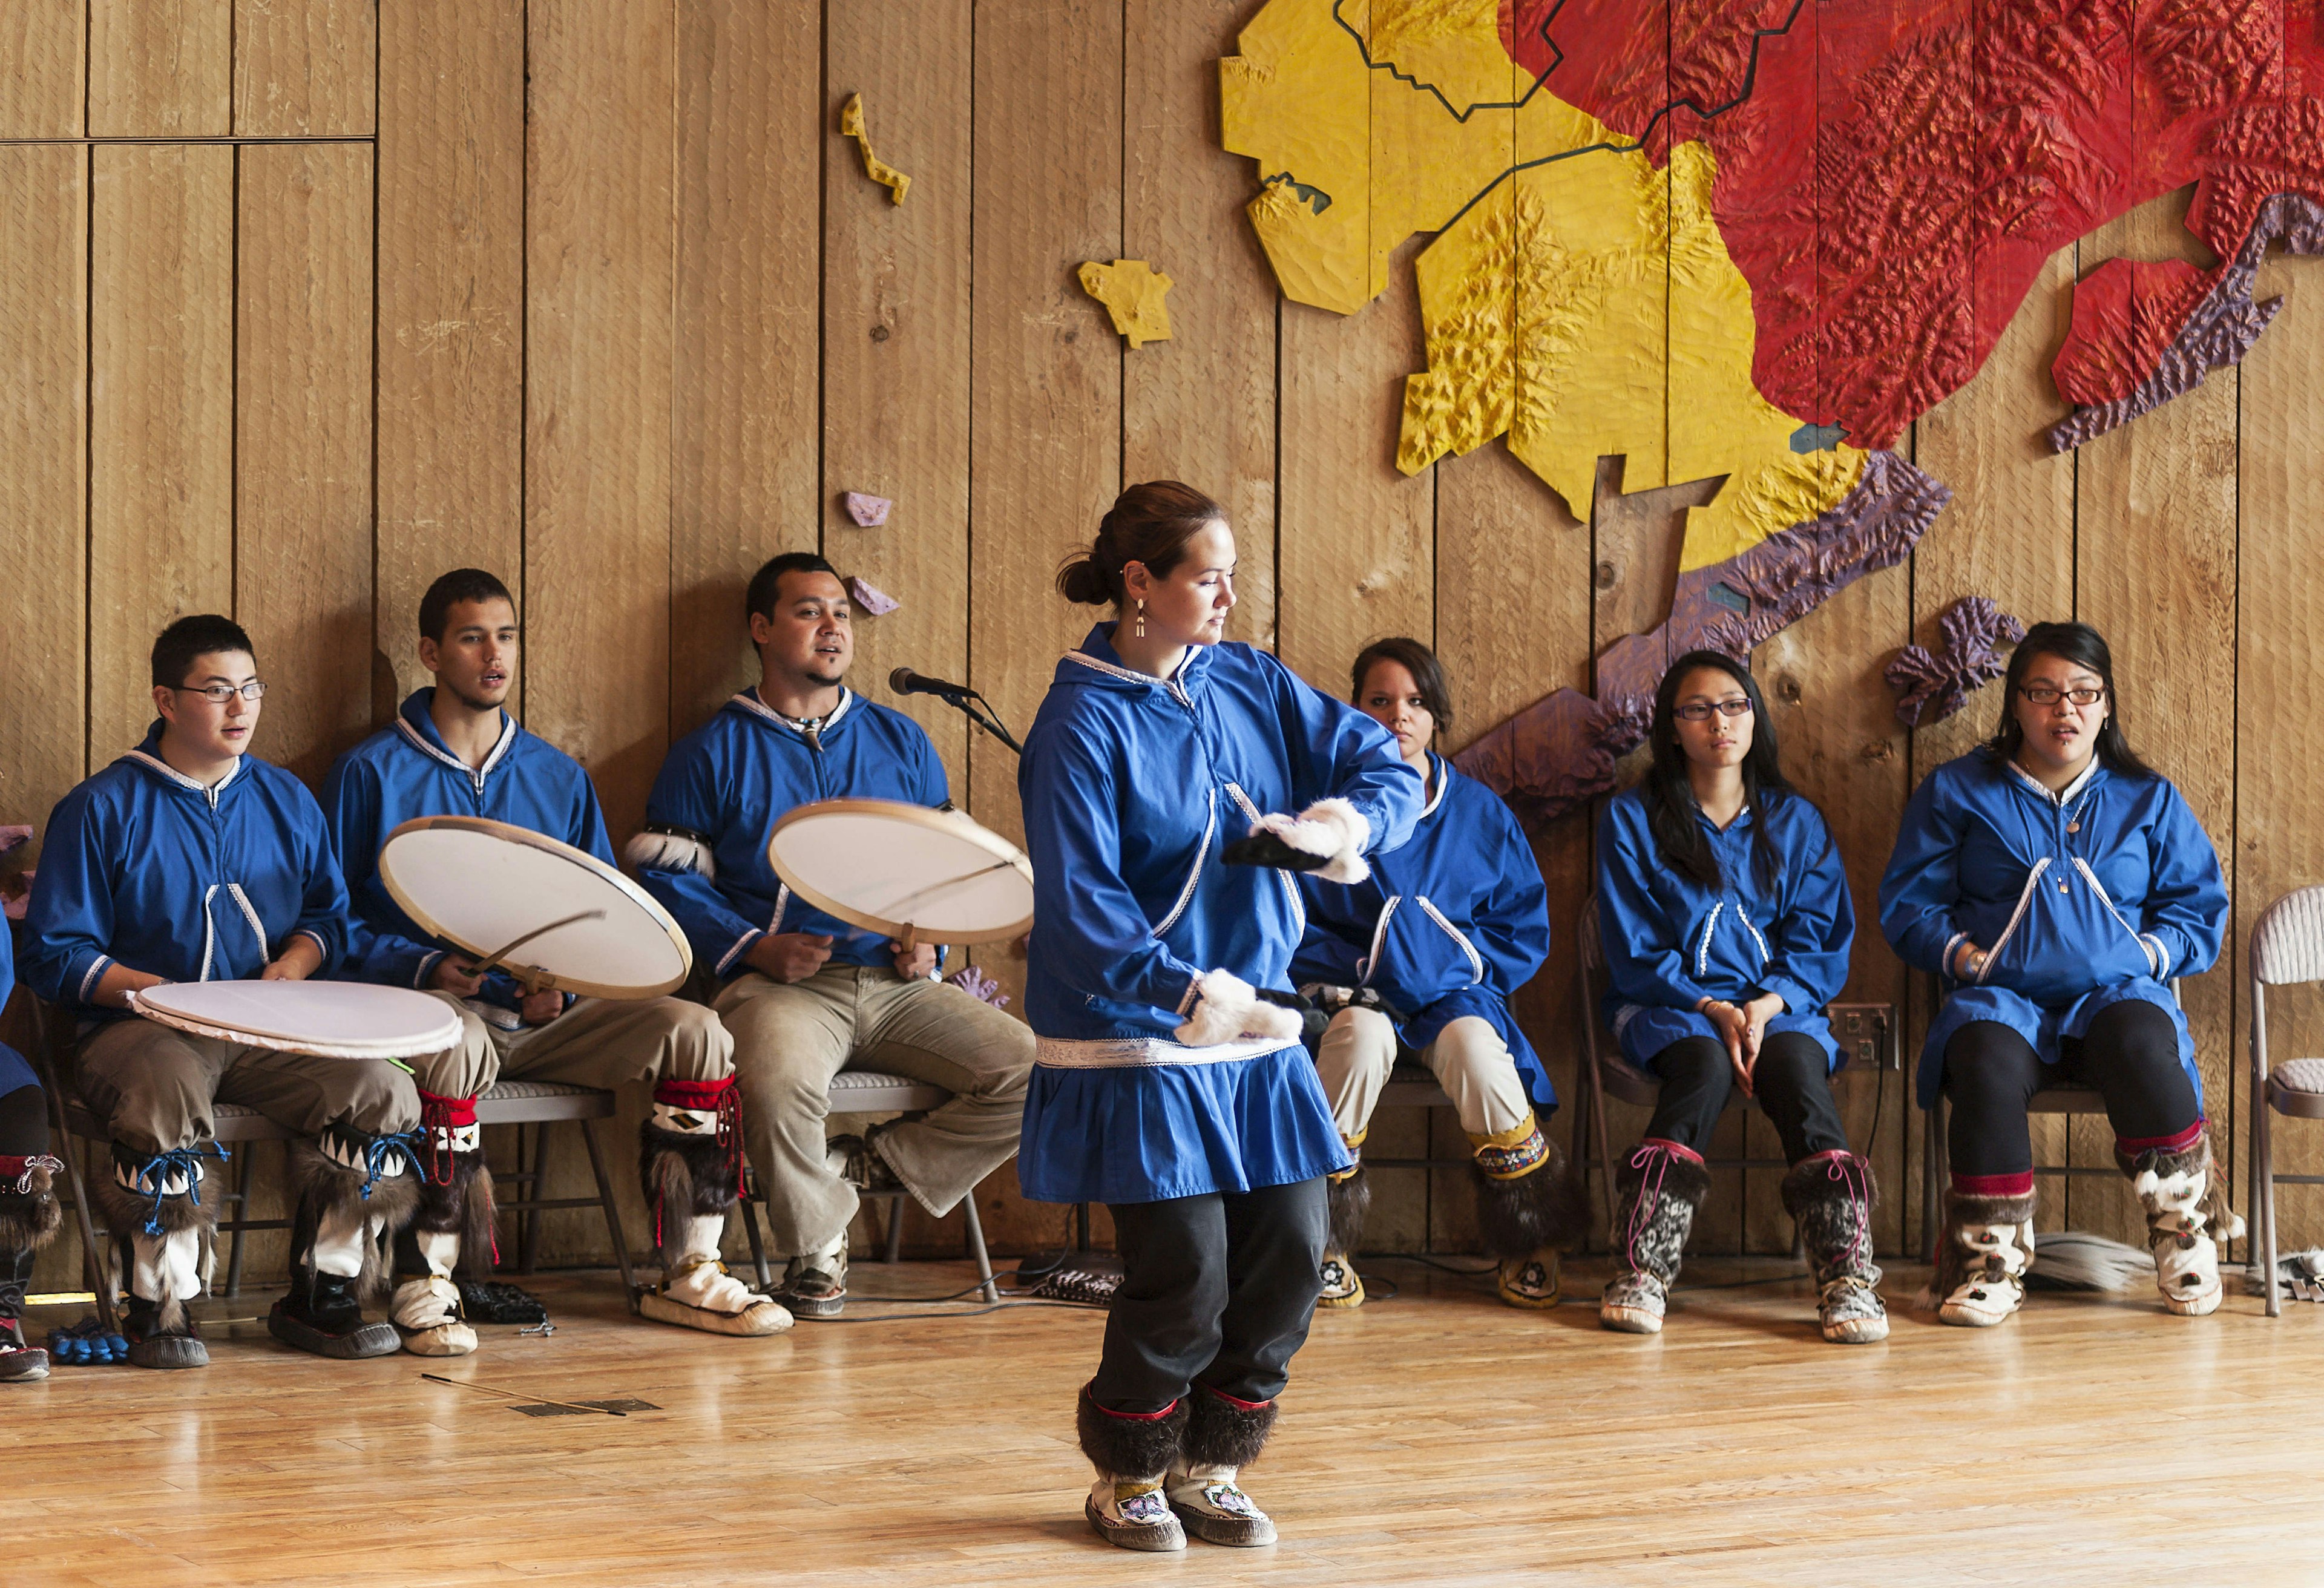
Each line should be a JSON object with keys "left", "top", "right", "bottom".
{"left": 2205, "top": 260, "right": 2324, "bottom": 1251}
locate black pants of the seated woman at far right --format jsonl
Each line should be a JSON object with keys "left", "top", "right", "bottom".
{"left": 1945, "top": 997, "right": 2203, "bottom": 1174}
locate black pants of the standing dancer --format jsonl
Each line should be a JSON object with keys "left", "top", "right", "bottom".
{"left": 1090, "top": 1179, "right": 1325, "bottom": 1411}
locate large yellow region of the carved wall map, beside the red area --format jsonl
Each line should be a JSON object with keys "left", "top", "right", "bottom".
{"left": 1220, "top": 0, "right": 1864, "bottom": 569}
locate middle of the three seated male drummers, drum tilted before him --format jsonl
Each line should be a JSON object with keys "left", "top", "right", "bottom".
{"left": 323, "top": 567, "right": 790, "bottom": 1356}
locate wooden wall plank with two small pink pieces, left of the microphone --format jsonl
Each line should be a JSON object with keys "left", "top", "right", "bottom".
{"left": 822, "top": 0, "right": 976, "bottom": 798}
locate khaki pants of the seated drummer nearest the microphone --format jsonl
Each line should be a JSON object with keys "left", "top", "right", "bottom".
{"left": 716, "top": 965, "right": 1032, "bottom": 1256}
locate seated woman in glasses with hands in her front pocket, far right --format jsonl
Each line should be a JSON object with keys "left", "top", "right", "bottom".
{"left": 1880, "top": 623, "right": 2240, "bottom": 1328}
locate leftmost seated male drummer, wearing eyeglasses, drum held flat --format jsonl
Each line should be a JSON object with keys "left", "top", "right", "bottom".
{"left": 23, "top": 616, "right": 421, "bottom": 1367}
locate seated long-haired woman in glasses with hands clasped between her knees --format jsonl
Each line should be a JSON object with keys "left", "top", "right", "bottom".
{"left": 1597, "top": 651, "right": 1887, "bottom": 1344}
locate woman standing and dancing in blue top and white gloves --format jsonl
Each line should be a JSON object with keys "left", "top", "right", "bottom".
{"left": 1018, "top": 481, "right": 1420, "bottom": 1551}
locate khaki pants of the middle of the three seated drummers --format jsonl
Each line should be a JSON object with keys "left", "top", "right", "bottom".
{"left": 412, "top": 993, "right": 734, "bottom": 1097}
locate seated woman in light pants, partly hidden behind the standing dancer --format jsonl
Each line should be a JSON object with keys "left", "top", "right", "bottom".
{"left": 1292, "top": 640, "right": 1590, "bottom": 1307}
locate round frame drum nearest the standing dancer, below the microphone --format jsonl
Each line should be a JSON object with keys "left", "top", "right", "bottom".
{"left": 767, "top": 800, "right": 1032, "bottom": 947}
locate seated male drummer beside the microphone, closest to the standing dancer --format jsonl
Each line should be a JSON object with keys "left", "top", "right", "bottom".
{"left": 630, "top": 551, "right": 1032, "bottom": 1318}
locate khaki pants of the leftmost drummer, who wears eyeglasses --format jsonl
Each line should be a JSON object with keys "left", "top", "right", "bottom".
{"left": 79, "top": 1019, "right": 421, "bottom": 1153}
